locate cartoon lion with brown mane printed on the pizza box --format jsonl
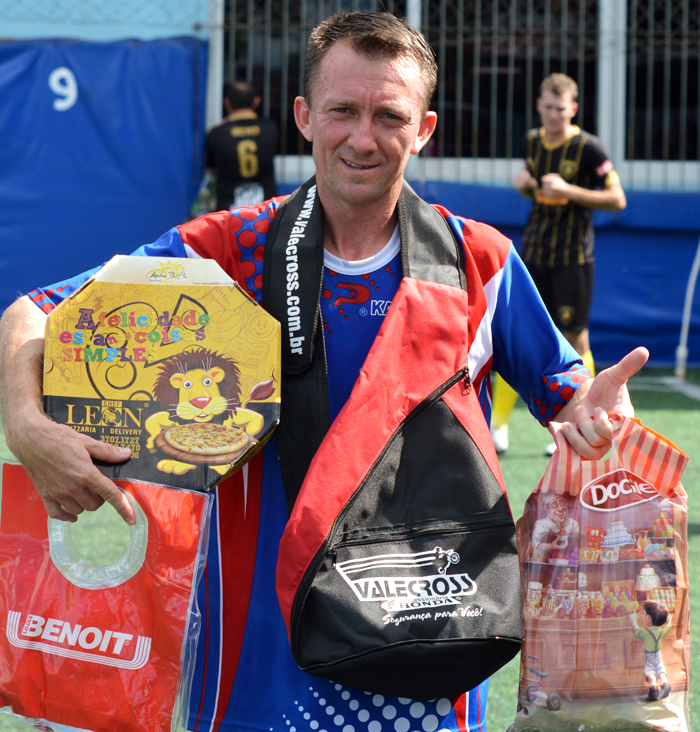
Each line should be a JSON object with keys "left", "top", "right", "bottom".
{"left": 146, "top": 347, "right": 269, "bottom": 475}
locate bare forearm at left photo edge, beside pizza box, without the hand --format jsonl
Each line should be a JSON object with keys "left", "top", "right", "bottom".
{"left": 0, "top": 297, "right": 46, "bottom": 449}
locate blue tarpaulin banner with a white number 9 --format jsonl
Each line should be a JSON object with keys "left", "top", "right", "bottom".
{"left": 0, "top": 37, "right": 207, "bottom": 311}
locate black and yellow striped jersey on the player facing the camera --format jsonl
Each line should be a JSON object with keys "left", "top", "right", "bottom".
{"left": 520, "top": 126, "right": 619, "bottom": 267}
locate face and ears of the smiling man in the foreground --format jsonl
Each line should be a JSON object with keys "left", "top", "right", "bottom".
{"left": 294, "top": 41, "right": 437, "bottom": 207}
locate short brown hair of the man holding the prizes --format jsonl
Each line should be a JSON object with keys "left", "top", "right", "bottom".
{"left": 304, "top": 12, "right": 437, "bottom": 114}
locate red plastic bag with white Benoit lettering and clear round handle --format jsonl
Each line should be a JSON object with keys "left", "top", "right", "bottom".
{"left": 0, "top": 465, "right": 212, "bottom": 732}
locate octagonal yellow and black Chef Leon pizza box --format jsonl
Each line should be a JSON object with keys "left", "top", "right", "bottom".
{"left": 44, "top": 256, "right": 281, "bottom": 491}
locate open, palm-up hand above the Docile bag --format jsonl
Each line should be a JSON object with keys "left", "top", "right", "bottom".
{"left": 556, "top": 347, "right": 649, "bottom": 460}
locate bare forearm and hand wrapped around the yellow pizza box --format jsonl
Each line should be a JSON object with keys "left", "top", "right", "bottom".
{"left": 0, "top": 297, "right": 135, "bottom": 524}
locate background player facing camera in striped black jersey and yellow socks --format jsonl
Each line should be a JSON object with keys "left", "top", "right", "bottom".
{"left": 491, "top": 74, "right": 627, "bottom": 454}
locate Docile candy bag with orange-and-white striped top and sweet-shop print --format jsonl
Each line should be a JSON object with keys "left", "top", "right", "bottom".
{"left": 511, "top": 415, "right": 690, "bottom": 732}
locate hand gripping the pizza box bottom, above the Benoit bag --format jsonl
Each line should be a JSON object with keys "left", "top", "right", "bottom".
{"left": 8, "top": 415, "right": 136, "bottom": 525}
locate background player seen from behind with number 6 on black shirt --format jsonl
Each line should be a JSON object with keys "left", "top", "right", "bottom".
{"left": 206, "top": 81, "right": 279, "bottom": 210}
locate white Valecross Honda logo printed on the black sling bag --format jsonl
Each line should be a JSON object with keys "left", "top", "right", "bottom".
{"left": 335, "top": 547, "right": 483, "bottom": 625}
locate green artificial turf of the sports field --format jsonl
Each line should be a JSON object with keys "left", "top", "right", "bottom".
{"left": 0, "top": 369, "right": 700, "bottom": 732}
